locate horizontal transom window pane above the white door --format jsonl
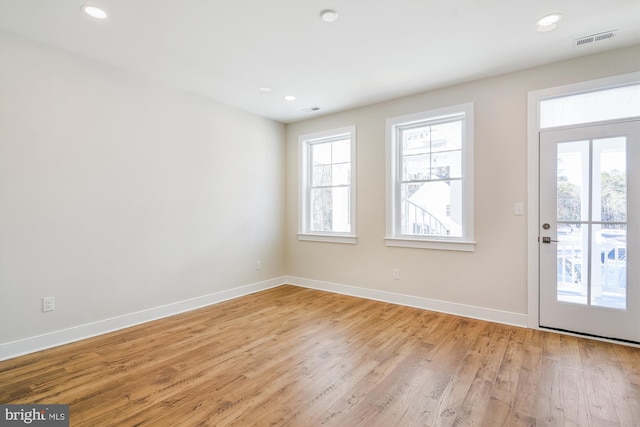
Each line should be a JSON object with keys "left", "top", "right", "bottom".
{"left": 540, "top": 85, "right": 640, "bottom": 129}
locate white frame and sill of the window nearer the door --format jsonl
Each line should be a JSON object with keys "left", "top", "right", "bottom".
{"left": 385, "top": 102, "right": 475, "bottom": 252}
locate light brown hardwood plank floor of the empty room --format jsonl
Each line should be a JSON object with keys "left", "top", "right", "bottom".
{"left": 0, "top": 286, "right": 640, "bottom": 427}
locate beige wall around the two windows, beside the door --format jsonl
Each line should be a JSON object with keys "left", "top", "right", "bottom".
{"left": 286, "top": 45, "right": 640, "bottom": 315}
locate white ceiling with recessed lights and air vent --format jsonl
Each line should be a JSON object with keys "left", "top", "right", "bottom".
{"left": 0, "top": 0, "right": 640, "bottom": 123}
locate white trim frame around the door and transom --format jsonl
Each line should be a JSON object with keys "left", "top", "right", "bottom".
{"left": 527, "top": 72, "right": 640, "bottom": 334}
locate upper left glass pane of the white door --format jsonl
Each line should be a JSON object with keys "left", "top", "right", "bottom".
{"left": 557, "top": 141, "right": 589, "bottom": 221}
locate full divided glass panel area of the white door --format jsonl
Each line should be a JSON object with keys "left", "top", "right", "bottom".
{"left": 556, "top": 137, "right": 627, "bottom": 310}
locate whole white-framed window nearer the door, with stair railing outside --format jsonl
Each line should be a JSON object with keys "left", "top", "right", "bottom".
{"left": 386, "top": 103, "right": 475, "bottom": 251}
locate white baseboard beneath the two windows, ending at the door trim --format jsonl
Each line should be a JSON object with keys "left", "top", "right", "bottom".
{"left": 284, "top": 276, "right": 528, "bottom": 328}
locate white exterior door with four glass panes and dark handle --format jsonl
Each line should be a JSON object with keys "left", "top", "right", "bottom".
{"left": 539, "top": 121, "right": 640, "bottom": 342}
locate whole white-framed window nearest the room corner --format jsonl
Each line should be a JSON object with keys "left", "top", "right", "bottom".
{"left": 298, "top": 126, "right": 356, "bottom": 243}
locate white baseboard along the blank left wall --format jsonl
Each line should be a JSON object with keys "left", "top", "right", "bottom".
{"left": 0, "top": 277, "right": 285, "bottom": 361}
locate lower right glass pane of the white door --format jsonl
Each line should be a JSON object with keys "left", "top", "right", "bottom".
{"left": 591, "top": 224, "right": 627, "bottom": 310}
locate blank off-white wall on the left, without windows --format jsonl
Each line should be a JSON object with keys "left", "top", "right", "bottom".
{"left": 0, "top": 32, "right": 285, "bottom": 344}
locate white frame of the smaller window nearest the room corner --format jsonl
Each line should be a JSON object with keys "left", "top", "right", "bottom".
{"left": 298, "top": 126, "right": 357, "bottom": 244}
